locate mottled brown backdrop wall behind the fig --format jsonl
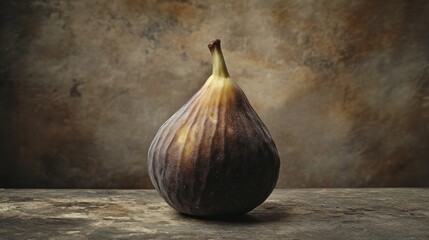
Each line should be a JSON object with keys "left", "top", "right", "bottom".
{"left": 0, "top": 0, "right": 429, "bottom": 188}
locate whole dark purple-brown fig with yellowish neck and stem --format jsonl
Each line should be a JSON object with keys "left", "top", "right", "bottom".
{"left": 147, "top": 39, "right": 280, "bottom": 217}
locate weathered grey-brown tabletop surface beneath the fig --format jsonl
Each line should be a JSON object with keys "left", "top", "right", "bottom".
{"left": 0, "top": 188, "right": 429, "bottom": 240}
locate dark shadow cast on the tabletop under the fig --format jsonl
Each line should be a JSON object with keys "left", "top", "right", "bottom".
{"left": 179, "top": 202, "right": 288, "bottom": 224}
